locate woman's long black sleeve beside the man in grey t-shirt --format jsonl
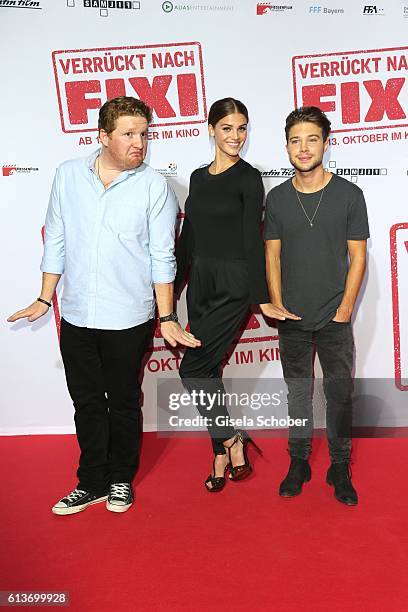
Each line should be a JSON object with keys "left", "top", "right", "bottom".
{"left": 242, "top": 169, "right": 270, "bottom": 304}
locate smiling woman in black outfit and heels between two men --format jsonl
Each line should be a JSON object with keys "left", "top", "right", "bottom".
{"left": 175, "top": 98, "right": 296, "bottom": 492}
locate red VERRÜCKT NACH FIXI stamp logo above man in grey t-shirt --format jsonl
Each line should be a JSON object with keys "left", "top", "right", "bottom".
{"left": 292, "top": 47, "right": 408, "bottom": 133}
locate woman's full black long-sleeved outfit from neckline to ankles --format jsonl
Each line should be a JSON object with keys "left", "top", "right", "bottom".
{"left": 175, "top": 159, "right": 269, "bottom": 453}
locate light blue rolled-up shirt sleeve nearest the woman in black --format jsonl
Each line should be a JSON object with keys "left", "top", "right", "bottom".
{"left": 149, "top": 180, "right": 178, "bottom": 283}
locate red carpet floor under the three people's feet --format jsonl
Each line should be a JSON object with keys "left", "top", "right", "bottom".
{"left": 0, "top": 434, "right": 408, "bottom": 612}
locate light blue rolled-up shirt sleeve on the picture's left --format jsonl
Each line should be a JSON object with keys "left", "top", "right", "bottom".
{"left": 40, "top": 169, "right": 65, "bottom": 274}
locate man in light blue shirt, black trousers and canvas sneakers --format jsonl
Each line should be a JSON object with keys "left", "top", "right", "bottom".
{"left": 8, "top": 96, "right": 200, "bottom": 515}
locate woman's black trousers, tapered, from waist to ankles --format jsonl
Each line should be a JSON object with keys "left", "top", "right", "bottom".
{"left": 180, "top": 256, "right": 249, "bottom": 454}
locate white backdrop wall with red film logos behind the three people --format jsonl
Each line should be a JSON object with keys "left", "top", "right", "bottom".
{"left": 0, "top": 0, "right": 408, "bottom": 434}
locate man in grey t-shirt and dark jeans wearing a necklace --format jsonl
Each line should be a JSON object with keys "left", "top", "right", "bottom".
{"left": 265, "top": 107, "right": 369, "bottom": 505}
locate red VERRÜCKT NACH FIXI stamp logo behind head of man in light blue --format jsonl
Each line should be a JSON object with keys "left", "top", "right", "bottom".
{"left": 52, "top": 42, "right": 207, "bottom": 133}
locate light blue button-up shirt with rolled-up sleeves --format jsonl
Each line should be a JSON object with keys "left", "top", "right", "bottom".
{"left": 41, "top": 150, "right": 177, "bottom": 329}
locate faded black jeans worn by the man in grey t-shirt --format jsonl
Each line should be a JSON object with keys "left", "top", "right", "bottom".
{"left": 278, "top": 320, "right": 354, "bottom": 463}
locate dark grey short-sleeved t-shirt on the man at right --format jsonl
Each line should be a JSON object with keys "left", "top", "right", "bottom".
{"left": 265, "top": 174, "right": 370, "bottom": 330}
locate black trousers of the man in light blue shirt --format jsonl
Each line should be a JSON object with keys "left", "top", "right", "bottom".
{"left": 60, "top": 319, "right": 153, "bottom": 493}
